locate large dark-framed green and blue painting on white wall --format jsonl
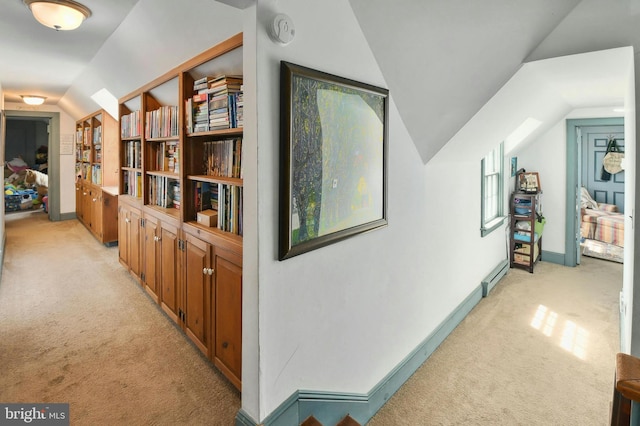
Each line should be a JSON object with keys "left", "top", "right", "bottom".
{"left": 278, "top": 61, "right": 389, "bottom": 260}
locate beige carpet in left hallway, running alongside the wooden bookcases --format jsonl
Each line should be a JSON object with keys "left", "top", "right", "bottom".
{"left": 0, "top": 211, "right": 240, "bottom": 426}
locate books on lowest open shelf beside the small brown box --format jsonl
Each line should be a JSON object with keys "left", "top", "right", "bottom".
{"left": 194, "top": 182, "right": 243, "bottom": 235}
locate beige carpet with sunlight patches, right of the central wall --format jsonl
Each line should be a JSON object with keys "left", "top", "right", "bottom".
{"left": 369, "top": 257, "right": 622, "bottom": 426}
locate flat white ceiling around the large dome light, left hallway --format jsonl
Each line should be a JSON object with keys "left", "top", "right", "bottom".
{"left": 0, "top": 0, "right": 138, "bottom": 105}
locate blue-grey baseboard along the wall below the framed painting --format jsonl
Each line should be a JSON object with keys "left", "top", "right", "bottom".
{"left": 236, "top": 285, "right": 483, "bottom": 426}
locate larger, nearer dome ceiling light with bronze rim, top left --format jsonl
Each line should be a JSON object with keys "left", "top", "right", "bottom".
{"left": 23, "top": 0, "right": 91, "bottom": 31}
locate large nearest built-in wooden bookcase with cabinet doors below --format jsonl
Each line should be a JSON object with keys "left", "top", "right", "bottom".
{"left": 114, "top": 34, "right": 243, "bottom": 389}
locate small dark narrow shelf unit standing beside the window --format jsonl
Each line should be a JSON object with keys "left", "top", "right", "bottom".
{"left": 510, "top": 192, "right": 545, "bottom": 272}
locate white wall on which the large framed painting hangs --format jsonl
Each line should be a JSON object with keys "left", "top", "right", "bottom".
{"left": 250, "top": 0, "right": 506, "bottom": 420}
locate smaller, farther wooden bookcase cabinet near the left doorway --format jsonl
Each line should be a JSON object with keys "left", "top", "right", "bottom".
{"left": 76, "top": 110, "right": 119, "bottom": 244}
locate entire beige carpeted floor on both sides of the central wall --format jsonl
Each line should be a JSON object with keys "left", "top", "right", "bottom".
{"left": 0, "top": 212, "right": 622, "bottom": 426}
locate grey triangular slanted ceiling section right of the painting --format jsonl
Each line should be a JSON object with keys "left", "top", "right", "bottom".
{"left": 350, "top": 0, "right": 579, "bottom": 163}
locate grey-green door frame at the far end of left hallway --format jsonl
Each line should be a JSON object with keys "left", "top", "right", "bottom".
{"left": 0, "top": 110, "right": 61, "bottom": 221}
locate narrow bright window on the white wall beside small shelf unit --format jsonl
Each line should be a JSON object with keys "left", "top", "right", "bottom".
{"left": 480, "top": 143, "right": 504, "bottom": 237}
